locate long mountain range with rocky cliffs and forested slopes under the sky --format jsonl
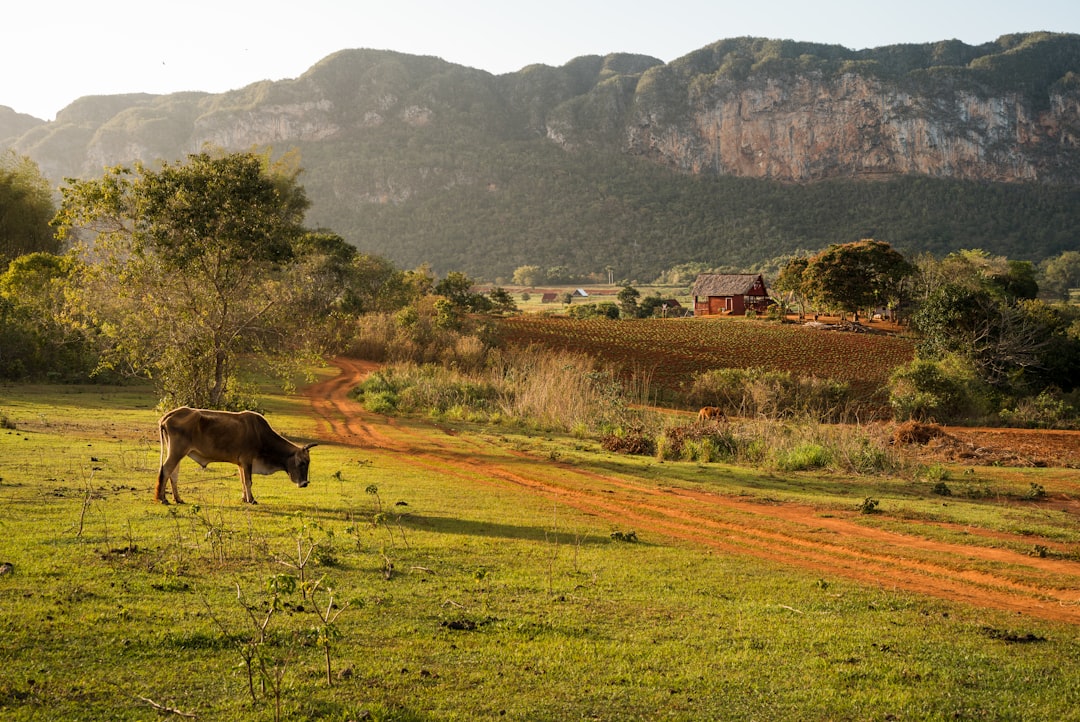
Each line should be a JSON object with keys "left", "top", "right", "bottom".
{"left": 0, "top": 32, "right": 1080, "bottom": 282}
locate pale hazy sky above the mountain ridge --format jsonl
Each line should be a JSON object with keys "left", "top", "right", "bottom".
{"left": 0, "top": 0, "right": 1080, "bottom": 120}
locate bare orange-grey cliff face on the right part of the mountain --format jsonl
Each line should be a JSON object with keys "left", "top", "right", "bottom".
{"left": 625, "top": 73, "right": 1062, "bottom": 182}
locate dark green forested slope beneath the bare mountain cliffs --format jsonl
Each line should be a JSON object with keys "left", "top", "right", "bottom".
{"left": 320, "top": 144, "right": 1080, "bottom": 283}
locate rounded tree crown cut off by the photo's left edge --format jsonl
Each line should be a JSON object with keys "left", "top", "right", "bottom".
{"left": 0, "top": 150, "right": 59, "bottom": 266}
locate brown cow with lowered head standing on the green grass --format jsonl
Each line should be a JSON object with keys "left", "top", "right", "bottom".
{"left": 154, "top": 406, "right": 315, "bottom": 504}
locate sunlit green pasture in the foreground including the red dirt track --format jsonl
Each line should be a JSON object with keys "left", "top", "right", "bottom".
{"left": 0, "top": 359, "right": 1080, "bottom": 720}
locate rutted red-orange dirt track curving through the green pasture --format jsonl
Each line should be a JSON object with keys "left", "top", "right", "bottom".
{"left": 306, "top": 358, "right": 1080, "bottom": 624}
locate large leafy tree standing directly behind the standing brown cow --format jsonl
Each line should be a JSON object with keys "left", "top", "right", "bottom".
{"left": 56, "top": 152, "right": 308, "bottom": 408}
